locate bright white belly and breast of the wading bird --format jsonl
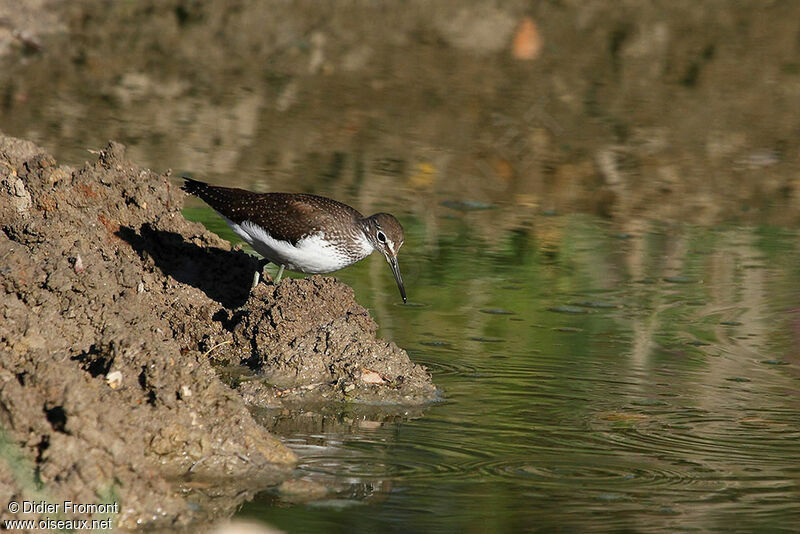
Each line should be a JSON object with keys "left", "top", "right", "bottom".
{"left": 225, "top": 218, "right": 374, "bottom": 274}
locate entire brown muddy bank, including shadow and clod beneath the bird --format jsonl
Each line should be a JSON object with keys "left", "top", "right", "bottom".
{"left": 0, "top": 137, "right": 435, "bottom": 527}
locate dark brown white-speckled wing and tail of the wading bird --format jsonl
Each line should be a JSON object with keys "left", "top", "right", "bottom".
{"left": 183, "top": 179, "right": 363, "bottom": 244}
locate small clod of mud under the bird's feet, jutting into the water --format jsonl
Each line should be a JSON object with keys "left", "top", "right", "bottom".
{"left": 225, "top": 276, "right": 436, "bottom": 406}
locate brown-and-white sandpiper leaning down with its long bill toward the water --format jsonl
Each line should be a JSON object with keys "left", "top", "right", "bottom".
{"left": 181, "top": 178, "right": 407, "bottom": 302}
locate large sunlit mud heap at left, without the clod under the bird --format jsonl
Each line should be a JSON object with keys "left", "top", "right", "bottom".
{"left": 0, "top": 138, "right": 294, "bottom": 526}
